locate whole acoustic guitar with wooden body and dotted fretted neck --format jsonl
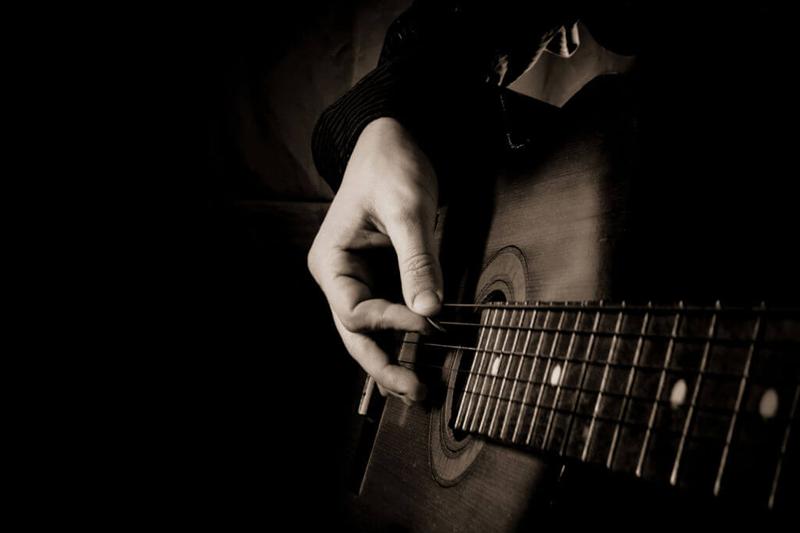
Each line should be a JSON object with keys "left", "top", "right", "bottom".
{"left": 344, "top": 77, "right": 800, "bottom": 531}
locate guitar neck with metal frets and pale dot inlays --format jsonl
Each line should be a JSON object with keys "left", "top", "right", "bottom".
{"left": 450, "top": 302, "right": 800, "bottom": 508}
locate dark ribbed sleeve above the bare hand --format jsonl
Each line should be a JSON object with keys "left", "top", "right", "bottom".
{"left": 312, "top": 0, "right": 576, "bottom": 190}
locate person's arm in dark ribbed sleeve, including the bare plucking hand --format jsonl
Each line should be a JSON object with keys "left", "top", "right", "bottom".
{"left": 308, "top": 0, "right": 635, "bottom": 403}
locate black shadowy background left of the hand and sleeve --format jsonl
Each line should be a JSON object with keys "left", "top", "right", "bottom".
{"left": 0, "top": 1, "right": 406, "bottom": 531}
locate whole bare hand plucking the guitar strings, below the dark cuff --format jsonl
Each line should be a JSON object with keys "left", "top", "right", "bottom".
{"left": 308, "top": 118, "right": 442, "bottom": 403}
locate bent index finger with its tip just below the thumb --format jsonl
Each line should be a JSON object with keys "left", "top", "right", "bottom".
{"left": 320, "top": 251, "right": 433, "bottom": 335}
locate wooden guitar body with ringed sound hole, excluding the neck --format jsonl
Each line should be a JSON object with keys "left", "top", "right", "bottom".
{"left": 352, "top": 77, "right": 793, "bottom": 532}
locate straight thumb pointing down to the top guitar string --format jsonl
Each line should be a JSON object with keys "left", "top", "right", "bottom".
{"left": 386, "top": 217, "right": 442, "bottom": 316}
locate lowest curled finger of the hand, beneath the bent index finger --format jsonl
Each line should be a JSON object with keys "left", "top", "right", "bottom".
{"left": 333, "top": 314, "right": 426, "bottom": 401}
